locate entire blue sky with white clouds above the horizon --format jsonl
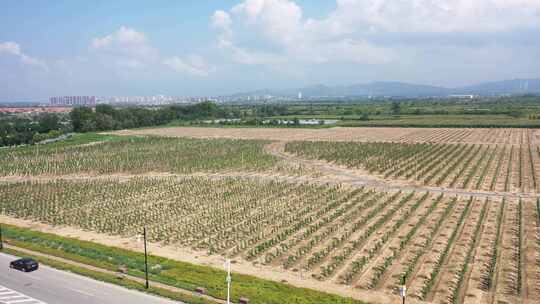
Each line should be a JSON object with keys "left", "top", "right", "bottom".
{"left": 0, "top": 0, "right": 540, "bottom": 101}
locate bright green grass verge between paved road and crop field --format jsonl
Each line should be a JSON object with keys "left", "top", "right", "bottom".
{"left": 2, "top": 225, "right": 363, "bottom": 304}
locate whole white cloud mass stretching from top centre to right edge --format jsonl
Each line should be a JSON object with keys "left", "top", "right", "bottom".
{"left": 211, "top": 0, "right": 540, "bottom": 66}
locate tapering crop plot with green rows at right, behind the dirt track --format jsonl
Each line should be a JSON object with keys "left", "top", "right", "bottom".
{"left": 285, "top": 141, "right": 540, "bottom": 192}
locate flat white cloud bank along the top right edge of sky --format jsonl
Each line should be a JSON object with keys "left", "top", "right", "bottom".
{"left": 329, "top": 0, "right": 540, "bottom": 32}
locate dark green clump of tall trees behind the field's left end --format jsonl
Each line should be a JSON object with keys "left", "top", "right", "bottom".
{"left": 0, "top": 102, "right": 224, "bottom": 146}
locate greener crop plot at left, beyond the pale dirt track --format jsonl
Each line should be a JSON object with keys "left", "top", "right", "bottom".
{"left": 0, "top": 137, "right": 276, "bottom": 176}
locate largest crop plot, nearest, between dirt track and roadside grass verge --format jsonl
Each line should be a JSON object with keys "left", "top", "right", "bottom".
{"left": 0, "top": 178, "right": 540, "bottom": 303}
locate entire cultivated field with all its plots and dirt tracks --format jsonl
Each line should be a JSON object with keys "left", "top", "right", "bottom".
{"left": 0, "top": 128, "right": 540, "bottom": 303}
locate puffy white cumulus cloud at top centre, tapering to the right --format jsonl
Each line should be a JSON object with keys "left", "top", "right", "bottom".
{"left": 211, "top": 0, "right": 394, "bottom": 68}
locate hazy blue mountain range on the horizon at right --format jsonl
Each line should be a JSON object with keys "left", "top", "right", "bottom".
{"left": 233, "top": 78, "right": 540, "bottom": 98}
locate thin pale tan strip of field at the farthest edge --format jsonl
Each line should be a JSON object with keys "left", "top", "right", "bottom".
{"left": 113, "top": 127, "right": 540, "bottom": 145}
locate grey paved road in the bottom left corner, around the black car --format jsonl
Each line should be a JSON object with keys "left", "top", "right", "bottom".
{"left": 0, "top": 253, "right": 180, "bottom": 304}
